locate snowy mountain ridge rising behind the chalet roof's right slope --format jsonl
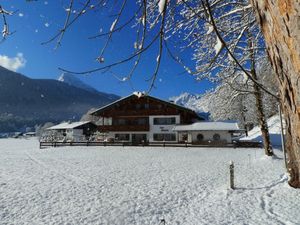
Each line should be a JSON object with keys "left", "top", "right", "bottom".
{"left": 170, "top": 92, "right": 209, "bottom": 113}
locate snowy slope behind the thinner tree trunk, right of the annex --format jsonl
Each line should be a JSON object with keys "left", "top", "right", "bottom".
{"left": 242, "top": 115, "right": 281, "bottom": 146}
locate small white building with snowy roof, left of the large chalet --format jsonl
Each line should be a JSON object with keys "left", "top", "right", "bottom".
{"left": 47, "top": 121, "right": 97, "bottom": 141}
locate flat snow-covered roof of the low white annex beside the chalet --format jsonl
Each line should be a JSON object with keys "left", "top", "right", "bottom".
{"left": 174, "top": 122, "right": 241, "bottom": 131}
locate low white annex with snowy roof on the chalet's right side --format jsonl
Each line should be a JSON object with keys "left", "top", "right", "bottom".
{"left": 174, "top": 121, "right": 244, "bottom": 144}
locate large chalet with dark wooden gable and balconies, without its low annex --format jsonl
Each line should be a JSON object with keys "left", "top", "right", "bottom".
{"left": 91, "top": 92, "right": 204, "bottom": 144}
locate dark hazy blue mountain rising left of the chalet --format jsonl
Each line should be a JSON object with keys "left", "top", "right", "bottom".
{"left": 0, "top": 67, "right": 119, "bottom": 132}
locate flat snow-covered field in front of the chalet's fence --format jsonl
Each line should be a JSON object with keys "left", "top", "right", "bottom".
{"left": 0, "top": 139, "right": 300, "bottom": 225}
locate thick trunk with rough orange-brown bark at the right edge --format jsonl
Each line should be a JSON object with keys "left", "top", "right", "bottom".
{"left": 251, "top": 0, "right": 300, "bottom": 188}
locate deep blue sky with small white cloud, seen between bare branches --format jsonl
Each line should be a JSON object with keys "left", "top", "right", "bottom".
{"left": 0, "top": 0, "right": 211, "bottom": 99}
